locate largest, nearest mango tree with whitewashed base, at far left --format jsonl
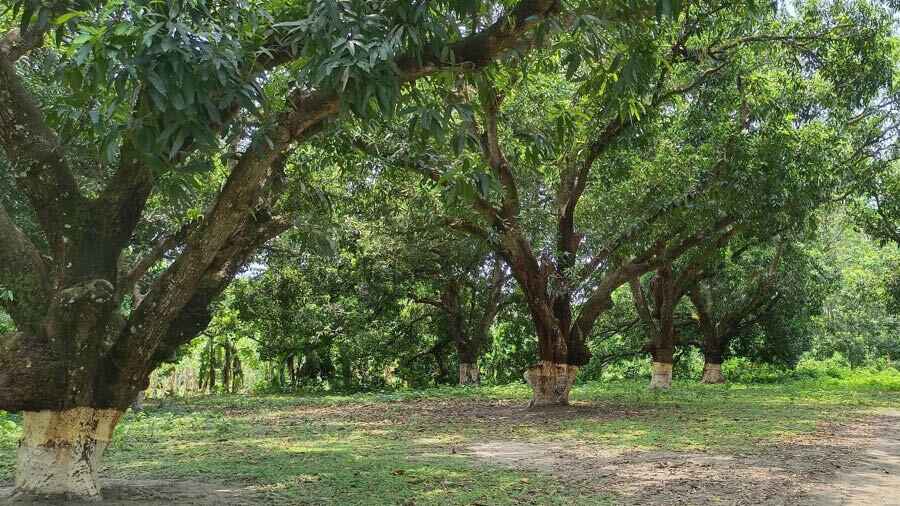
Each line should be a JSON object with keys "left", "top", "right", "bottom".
{"left": 0, "top": 0, "right": 568, "bottom": 498}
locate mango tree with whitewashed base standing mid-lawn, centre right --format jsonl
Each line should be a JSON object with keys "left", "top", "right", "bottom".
{"left": 390, "top": 2, "right": 890, "bottom": 406}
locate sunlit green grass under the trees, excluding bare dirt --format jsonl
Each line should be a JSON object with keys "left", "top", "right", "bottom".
{"left": 0, "top": 373, "right": 900, "bottom": 505}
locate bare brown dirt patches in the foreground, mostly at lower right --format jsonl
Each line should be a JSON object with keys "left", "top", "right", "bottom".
{"left": 0, "top": 406, "right": 900, "bottom": 506}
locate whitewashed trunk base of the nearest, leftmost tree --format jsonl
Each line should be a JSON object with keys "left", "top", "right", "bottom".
{"left": 15, "top": 408, "right": 122, "bottom": 500}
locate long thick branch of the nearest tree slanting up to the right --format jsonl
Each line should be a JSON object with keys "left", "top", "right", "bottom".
{"left": 109, "top": 0, "right": 558, "bottom": 392}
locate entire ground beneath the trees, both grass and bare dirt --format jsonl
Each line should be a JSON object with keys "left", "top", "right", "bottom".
{"left": 0, "top": 370, "right": 900, "bottom": 506}
